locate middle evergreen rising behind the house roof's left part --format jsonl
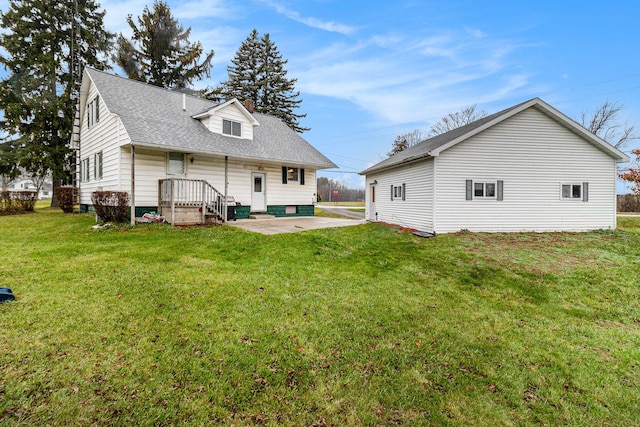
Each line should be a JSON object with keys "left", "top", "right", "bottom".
{"left": 114, "top": 0, "right": 214, "bottom": 89}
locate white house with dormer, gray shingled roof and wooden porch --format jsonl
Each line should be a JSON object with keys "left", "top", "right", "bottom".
{"left": 72, "top": 68, "right": 336, "bottom": 223}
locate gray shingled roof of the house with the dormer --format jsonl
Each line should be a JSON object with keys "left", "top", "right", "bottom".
{"left": 86, "top": 68, "right": 337, "bottom": 169}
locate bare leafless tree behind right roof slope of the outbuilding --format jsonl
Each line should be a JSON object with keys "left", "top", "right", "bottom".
{"left": 581, "top": 101, "right": 640, "bottom": 148}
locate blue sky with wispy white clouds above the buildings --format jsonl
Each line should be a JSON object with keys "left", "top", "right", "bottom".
{"left": 0, "top": 0, "right": 640, "bottom": 190}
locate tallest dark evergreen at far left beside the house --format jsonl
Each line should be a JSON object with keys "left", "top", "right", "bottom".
{"left": 0, "top": 0, "right": 113, "bottom": 201}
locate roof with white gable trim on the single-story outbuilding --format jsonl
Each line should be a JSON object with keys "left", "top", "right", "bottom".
{"left": 360, "top": 98, "right": 629, "bottom": 175}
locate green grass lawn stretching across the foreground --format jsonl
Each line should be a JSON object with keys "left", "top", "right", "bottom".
{"left": 0, "top": 209, "right": 640, "bottom": 426}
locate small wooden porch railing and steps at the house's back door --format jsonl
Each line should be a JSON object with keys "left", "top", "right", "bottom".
{"left": 158, "top": 178, "right": 225, "bottom": 224}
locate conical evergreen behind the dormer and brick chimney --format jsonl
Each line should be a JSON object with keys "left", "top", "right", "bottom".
{"left": 219, "top": 29, "right": 309, "bottom": 132}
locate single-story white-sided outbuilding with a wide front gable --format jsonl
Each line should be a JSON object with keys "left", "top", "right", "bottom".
{"left": 361, "top": 98, "right": 629, "bottom": 233}
